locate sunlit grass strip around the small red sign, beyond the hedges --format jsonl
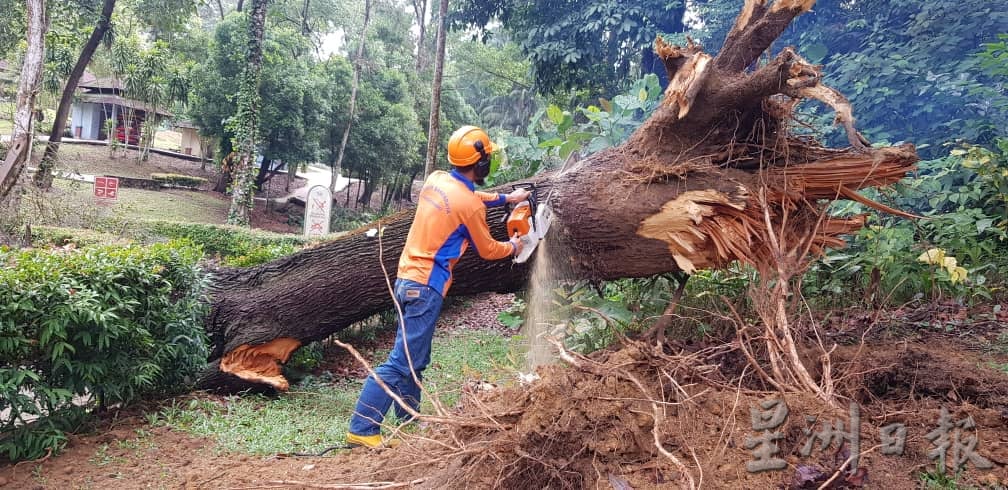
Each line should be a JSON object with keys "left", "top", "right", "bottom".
{"left": 54, "top": 179, "right": 230, "bottom": 225}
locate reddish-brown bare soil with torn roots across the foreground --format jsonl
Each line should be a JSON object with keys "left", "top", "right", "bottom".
{"left": 0, "top": 298, "right": 1008, "bottom": 489}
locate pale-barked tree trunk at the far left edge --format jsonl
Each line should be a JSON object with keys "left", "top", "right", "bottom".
{"left": 0, "top": 0, "right": 49, "bottom": 204}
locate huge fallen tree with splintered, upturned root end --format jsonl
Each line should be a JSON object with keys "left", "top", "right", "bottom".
{"left": 202, "top": 0, "right": 917, "bottom": 390}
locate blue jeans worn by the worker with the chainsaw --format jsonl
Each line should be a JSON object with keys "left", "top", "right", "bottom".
{"left": 350, "top": 279, "right": 444, "bottom": 436}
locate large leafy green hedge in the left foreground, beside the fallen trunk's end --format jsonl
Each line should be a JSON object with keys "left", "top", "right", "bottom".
{"left": 0, "top": 241, "right": 208, "bottom": 460}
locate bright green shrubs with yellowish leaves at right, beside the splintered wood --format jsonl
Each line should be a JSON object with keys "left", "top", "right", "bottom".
{"left": 804, "top": 144, "right": 1008, "bottom": 303}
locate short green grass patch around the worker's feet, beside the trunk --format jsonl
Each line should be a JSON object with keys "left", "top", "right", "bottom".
{"left": 157, "top": 331, "right": 516, "bottom": 455}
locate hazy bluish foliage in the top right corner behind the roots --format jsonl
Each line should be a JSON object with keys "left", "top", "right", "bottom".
{"left": 777, "top": 0, "right": 1008, "bottom": 154}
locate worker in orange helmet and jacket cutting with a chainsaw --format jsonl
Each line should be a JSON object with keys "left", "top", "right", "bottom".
{"left": 347, "top": 126, "right": 529, "bottom": 448}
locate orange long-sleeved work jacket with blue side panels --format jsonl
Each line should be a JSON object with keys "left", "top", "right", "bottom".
{"left": 397, "top": 169, "right": 514, "bottom": 295}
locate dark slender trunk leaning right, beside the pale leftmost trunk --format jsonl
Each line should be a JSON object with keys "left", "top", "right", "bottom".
{"left": 34, "top": 0, "right": 115, "bottom": 189}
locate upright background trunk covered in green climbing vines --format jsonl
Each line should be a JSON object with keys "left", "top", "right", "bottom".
{"left": 228, "top": 0, "right": 269, "bottom": 226}
